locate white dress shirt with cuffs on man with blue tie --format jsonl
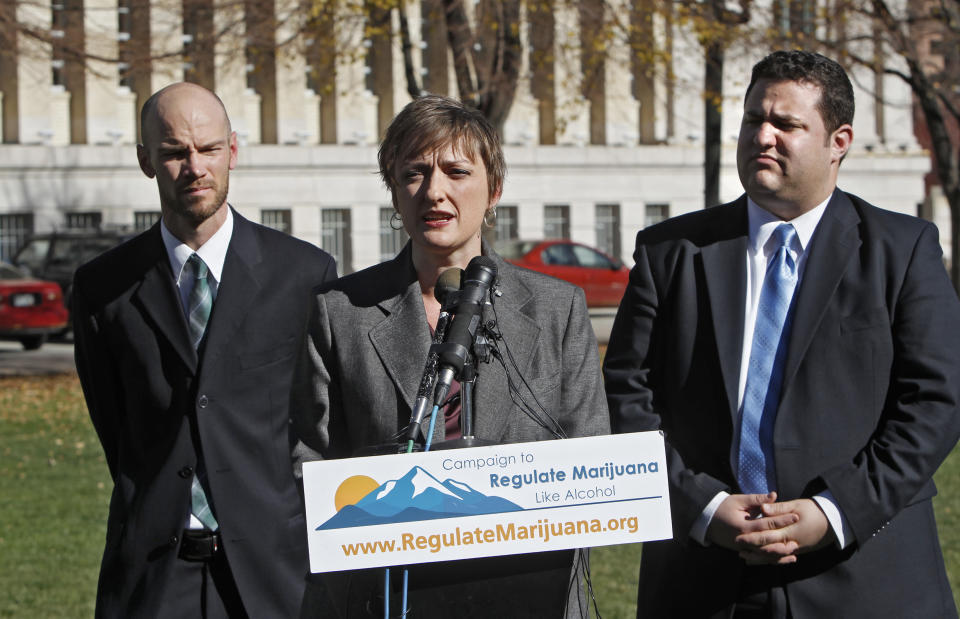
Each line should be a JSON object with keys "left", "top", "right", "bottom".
{"left": 690, "top": 197, "right": 853, "bottom": 548}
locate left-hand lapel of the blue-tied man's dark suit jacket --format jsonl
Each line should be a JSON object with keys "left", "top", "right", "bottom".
{"left": 701, "top": 196, "right": 749, "bottom": 421}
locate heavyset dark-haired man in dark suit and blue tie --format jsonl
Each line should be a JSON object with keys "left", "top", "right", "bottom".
{"left": 605, "top": 51, "right": 960, "bottom": 618}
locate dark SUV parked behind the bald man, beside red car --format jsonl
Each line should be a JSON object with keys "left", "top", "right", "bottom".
{"left": 11, "top": 230, "right": 135, "bottom": 322}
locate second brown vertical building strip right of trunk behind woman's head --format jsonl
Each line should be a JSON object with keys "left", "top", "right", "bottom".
{"left": 577, "top": 0, "right": 607, "bottom": 144}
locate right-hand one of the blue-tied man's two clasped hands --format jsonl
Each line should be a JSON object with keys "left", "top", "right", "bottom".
{"left": 736, "top": 499, "right": 833, "bottom": 565}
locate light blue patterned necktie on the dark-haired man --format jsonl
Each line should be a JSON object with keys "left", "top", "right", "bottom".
{"left": 737, "top": 223, "right": 797, "bottom": 494}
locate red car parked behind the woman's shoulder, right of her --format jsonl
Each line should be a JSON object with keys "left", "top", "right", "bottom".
{"left": 496, "top": 239, "right": 630, "bottom": 307}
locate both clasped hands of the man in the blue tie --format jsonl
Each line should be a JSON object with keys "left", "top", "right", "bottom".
{"left": 707, "top": 492, "right": 832, "bottom": 565}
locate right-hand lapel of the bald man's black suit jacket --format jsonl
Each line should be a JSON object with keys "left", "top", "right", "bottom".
{"left": 203, "top": 211, "right": 262, "bottom": 370}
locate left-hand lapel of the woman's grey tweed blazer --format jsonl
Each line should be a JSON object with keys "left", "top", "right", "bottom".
{"left": 368, "top": 249, "right": 434, "bottom": 432}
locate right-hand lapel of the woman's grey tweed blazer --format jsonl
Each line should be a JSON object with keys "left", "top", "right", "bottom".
{"left": 473, "top": 250, "right": 540, "bottom": 443}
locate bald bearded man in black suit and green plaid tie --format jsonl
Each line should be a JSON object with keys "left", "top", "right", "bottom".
{"left": 73, "top": 83, "right": 336, "bottom": 618}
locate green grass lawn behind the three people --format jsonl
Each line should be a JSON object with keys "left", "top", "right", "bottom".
{"left": 0, "top": 376, "right": 960, "bottom": 619}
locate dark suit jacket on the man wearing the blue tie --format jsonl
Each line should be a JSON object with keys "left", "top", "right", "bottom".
{"left": 605, "top": 190, "right": 960, "bottom": 618}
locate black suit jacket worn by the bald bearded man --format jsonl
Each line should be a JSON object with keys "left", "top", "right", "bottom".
{"left": 73, "top": 213, "right": 336, "bottom": 617}
